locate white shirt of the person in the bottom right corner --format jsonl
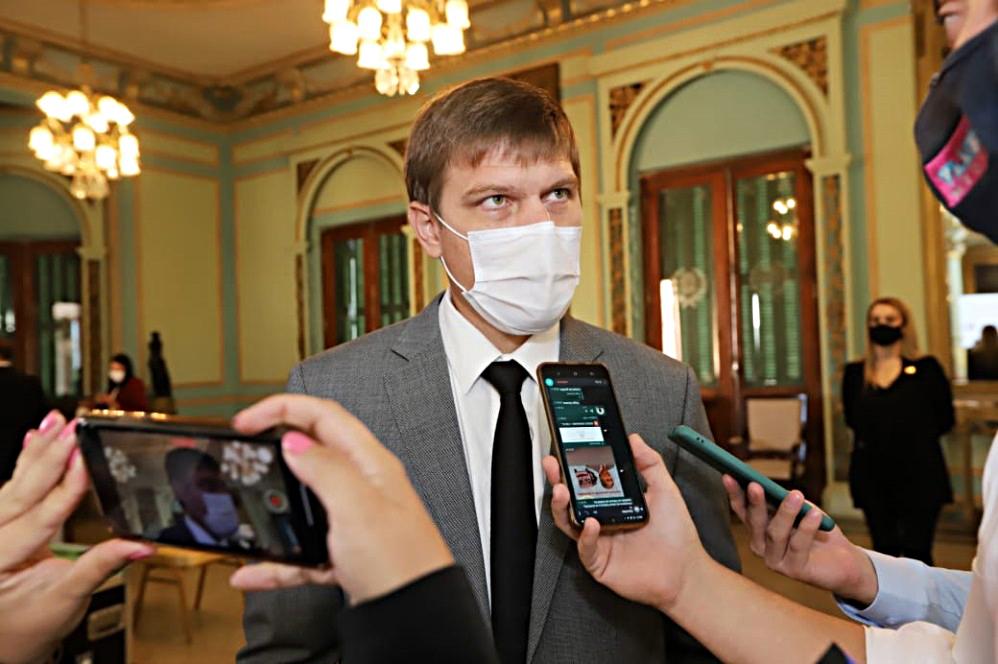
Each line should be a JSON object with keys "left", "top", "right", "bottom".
{"left": 866, "top": 436, "right": 998, "bottom": 664}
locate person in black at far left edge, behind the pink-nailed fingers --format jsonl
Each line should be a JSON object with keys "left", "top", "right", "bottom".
{"left": 0, "top": 343, "right": 48, "bottom": 484}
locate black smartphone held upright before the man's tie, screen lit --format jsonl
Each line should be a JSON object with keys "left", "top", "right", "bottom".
{"left": 537, "top": 362, "right": 648, "bottom": 530}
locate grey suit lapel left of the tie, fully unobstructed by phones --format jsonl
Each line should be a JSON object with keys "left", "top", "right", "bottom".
{"left": 385, "top": 299, "right": 489, "bottom": 616}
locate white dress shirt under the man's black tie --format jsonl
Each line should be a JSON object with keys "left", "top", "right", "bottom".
{"left": 439, "top": 289, "right": 561, "bottom": 598}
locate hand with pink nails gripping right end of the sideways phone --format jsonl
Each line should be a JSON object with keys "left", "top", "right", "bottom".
{"left": 232, "top": 394, "right": 454, "bottom": 604}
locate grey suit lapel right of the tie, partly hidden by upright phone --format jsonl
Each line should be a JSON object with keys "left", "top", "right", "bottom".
{"left": 527, "top": 316, "right": 603, "bottom": 662}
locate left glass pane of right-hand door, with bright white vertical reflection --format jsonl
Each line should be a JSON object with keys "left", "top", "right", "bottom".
{"left": 658, "top": 184, "right": 717, "bottom": 387}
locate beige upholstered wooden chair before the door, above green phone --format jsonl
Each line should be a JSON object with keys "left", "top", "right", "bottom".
{"left": 730, "top": 394, "right": 807, "bottom": 485}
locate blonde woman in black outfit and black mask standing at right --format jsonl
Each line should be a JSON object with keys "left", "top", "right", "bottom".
{"left": 842, "top": 297, "right": 954, "bottom": 565}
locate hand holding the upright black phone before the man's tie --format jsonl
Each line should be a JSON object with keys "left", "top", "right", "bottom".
{"left": 543, "top": 434, "right": 709, "bottom": 610}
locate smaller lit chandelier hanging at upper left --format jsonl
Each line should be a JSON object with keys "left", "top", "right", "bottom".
{"left": 28, "top": 85, "right": 139, "bottom": 199}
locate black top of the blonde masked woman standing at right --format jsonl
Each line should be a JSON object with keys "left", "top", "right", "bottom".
{"left": 842, "top": 356, "right": 955, "bottom": 507}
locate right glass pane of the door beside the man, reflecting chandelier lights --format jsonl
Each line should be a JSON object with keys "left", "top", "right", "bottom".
{"left": 735, "top": 171, "right": 804, "bottom": 387}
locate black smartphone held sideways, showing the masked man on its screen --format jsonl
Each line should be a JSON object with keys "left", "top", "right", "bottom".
{"left": 76, "top": 412, "right": 329, "bottom": 566}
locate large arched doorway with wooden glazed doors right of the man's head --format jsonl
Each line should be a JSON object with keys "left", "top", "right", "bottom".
{"left": 629, "top": 70, "right": 824, "bottom": 495}
